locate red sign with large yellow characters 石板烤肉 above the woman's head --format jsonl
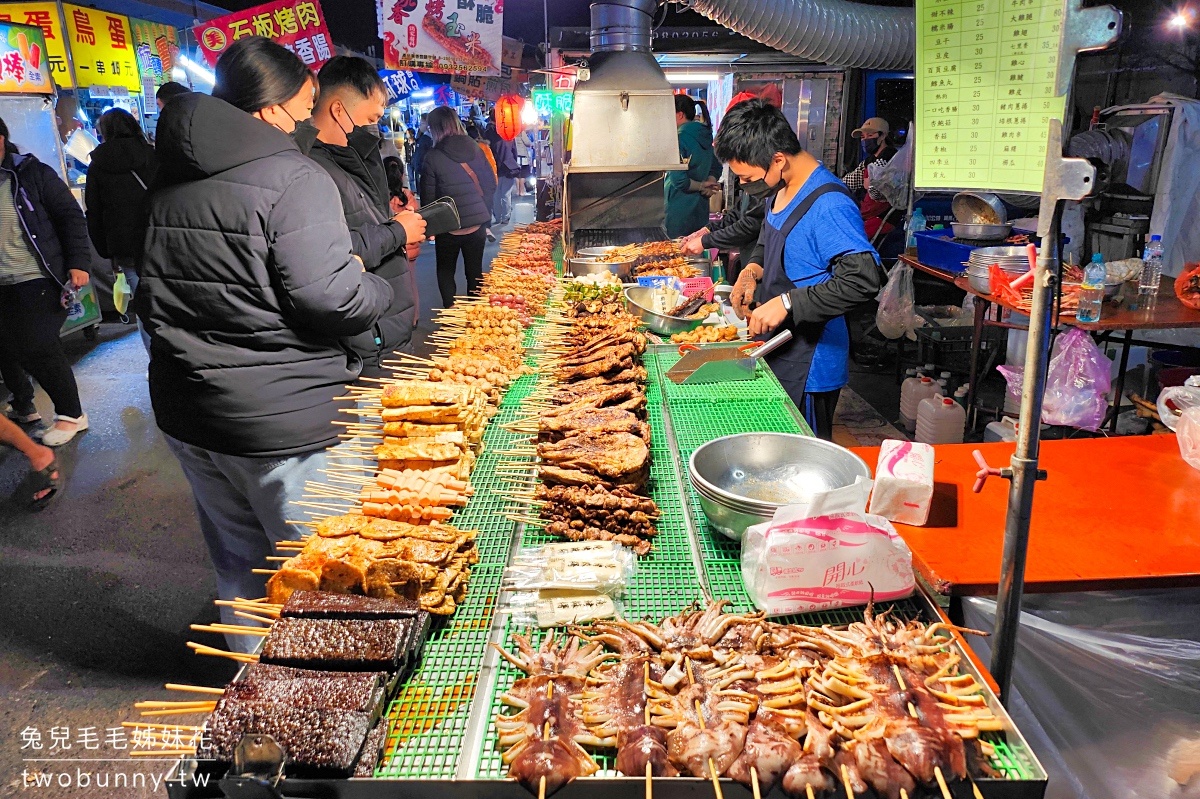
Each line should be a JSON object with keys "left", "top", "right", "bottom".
{"left": 192, "top": 0, "right": 334, "bottom": 70}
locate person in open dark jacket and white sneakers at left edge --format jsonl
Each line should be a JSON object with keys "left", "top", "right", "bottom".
{"left": 0, "top": 119, "right": 91, "bottom": 446}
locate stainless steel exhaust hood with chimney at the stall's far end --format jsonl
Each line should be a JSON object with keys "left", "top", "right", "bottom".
{"left": 563, "top": 0, "right": 686, "bottom": 244}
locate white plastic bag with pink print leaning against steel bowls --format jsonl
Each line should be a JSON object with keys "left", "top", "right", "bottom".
{"left": 742, "top": 480, "right": 914, "bottom": 615}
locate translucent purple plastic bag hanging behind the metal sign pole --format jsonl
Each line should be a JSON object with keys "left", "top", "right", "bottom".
{"left": 996, "top": 328, "right": 1112, "bottom": 431}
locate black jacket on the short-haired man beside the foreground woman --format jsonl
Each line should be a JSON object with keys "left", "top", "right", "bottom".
{"left": 301, "top": 131, "right": 416, "bottom": 376}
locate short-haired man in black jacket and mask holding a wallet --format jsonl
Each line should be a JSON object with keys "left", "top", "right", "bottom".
{"left": 296, "top": 55, "right": 425, "bottom": 377}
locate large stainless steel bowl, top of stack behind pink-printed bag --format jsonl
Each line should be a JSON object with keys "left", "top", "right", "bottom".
{"left": 688, "top": 433, "right": 871, "bottom": 512}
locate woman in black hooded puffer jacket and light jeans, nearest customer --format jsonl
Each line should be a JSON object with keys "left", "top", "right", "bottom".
{"left": 136, "top": 37, "right": 391, "bottom": 648}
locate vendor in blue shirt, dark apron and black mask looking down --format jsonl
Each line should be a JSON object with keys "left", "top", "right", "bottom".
{"left": 716, "top": 100, "right": 883, "bottom": 439}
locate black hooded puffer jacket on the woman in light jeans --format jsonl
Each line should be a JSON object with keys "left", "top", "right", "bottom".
{"left": 136, "top": 94, "right": 391, "bottom": 458}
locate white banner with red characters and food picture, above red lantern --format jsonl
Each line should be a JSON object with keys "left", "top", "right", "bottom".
{"left": 379, "top": 0, "right": 504, "bottom": 76}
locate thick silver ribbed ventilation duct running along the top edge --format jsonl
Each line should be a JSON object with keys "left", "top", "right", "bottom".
{"left": 689, "top": 0, "right": 917, "bottom": 70}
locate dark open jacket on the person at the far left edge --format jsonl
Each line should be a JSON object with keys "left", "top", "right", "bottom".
{"left": 0, "top": 154, "right": 91, "bottom": 286}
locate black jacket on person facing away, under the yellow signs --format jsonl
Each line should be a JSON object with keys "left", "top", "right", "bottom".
{"left": 84, "top": 138, "right": 158, "bottom": 258}
